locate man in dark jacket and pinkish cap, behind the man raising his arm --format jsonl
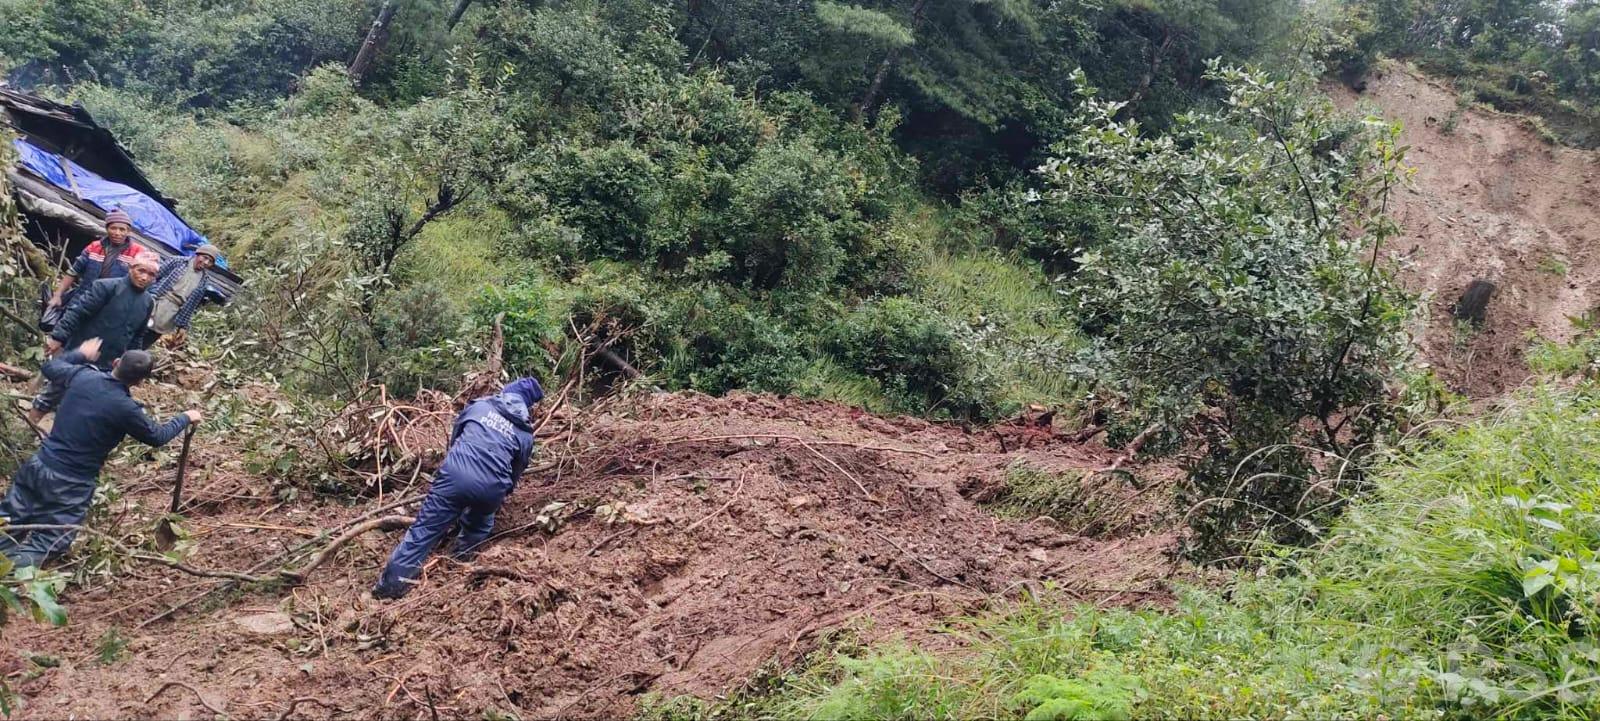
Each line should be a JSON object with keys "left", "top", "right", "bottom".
{"left": 27, "top": 253, "right": 157, "bottom": 425}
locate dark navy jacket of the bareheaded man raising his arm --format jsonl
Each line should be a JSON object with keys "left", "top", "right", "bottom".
{"left": 38, "top": 350, "right": 189, "bottom": 480}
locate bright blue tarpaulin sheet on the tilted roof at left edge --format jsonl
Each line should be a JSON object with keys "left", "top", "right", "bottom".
{"left": 13, "top": 139, "right": 227, "bottom": 269}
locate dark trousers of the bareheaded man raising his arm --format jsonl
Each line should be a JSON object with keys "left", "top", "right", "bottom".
{"left": 0, "top": 456, "right": 94, "bottom": 568}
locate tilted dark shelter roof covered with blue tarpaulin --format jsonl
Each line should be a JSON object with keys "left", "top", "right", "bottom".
{"left": 0, "top": 88, "right": 243, "bottom": 304}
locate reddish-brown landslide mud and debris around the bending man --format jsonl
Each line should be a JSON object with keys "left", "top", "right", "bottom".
{"left": 0, "top": 395, "right": 1173, "bottom": 719}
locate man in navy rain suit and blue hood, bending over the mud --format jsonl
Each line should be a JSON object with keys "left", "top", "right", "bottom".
{"left": 373, "top": 377, "right": 544, "bottom": 598}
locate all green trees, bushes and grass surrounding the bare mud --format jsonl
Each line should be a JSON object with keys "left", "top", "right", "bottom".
{"left": 0, "top": 0, "right": 1600, "bottom": 718}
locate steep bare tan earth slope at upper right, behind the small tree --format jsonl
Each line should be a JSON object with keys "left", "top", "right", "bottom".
{"left": 1341, "top": 64, "right": 1600, "bottom": 398}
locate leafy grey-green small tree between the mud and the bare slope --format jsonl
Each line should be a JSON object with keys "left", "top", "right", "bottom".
{"left": 1043, "top": 64, "right": 1408, "bottom": 560}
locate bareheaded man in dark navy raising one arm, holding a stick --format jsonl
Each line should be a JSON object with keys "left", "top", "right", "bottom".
{"left": 0, "top": 337, "right": 203, "bottom": 568}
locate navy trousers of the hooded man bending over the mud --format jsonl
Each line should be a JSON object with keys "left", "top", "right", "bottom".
{"left": 373, "top": 473, "right": 506, "bottom": 598}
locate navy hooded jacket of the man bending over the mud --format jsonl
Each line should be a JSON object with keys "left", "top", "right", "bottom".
{"left": 435, "top": 395, "right": 533, "bottom": 492}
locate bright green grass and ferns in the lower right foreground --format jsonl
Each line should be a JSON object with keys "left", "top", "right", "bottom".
{"left": 646, "top": 385, "right": 1600, "bottom": 719}
